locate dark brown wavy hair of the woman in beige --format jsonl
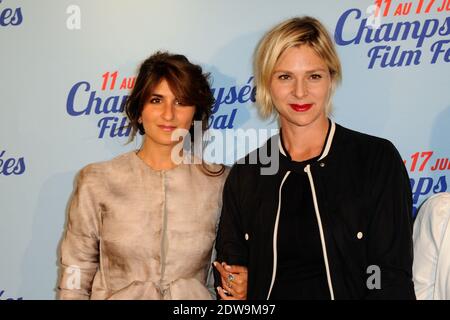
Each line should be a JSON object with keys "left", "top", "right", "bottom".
{"left": 124, "top": 51, "right": 224, "bottom": 175}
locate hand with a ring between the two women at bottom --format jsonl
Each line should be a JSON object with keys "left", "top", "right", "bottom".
{"left": 214, "top": 261, "right": 248, "bottom": 300}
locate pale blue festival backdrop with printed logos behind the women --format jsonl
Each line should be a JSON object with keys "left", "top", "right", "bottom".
{"left": 0, "top": 0, "right": 450, "bottom": 299}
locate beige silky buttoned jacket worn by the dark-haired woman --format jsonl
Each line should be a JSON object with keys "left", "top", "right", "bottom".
{"left": 58, "top": 151, "right": 228, "bottom": 300}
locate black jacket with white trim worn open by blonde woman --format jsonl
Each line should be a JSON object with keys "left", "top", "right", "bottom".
{"left": 215, "top": 122, "right": 415, "bottom": 300}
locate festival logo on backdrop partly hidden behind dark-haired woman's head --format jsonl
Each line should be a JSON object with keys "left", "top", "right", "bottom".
{"left": 66, "top": 71, "right": 256, "bottom": 139}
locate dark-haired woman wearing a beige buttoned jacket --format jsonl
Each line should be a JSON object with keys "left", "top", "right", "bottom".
{"left": 58, "top": 52, "right": 241, "bottom": 300}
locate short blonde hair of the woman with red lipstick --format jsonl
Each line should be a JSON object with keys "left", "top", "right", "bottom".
{"left": 253, "top": 16, "right": 342, "bottom": 118}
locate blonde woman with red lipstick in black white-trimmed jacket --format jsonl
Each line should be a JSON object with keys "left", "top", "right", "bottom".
{"left": 216, "top": 17, "right": 415, "bottom": 300}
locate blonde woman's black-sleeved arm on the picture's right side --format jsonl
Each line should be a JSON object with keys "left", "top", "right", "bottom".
{"left": 366, "top": 142, "right": 415, "bottom": 299}
